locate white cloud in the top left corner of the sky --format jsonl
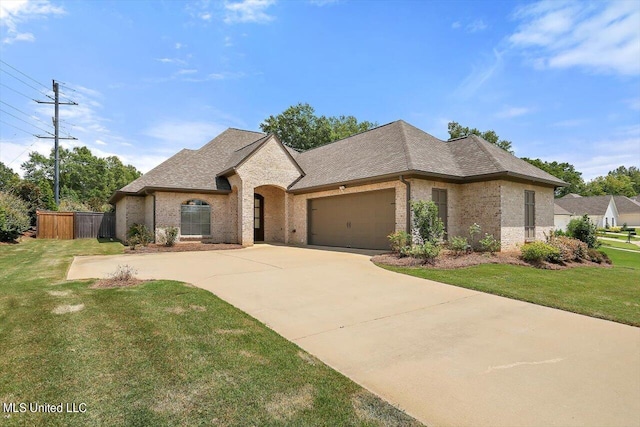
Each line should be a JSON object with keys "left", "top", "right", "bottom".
{"left": 0, "top": 0, "right": 65, "bottom": 44}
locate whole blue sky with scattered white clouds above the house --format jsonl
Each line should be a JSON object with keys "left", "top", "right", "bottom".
{"left": 0, "top": 0, "right": 640, "bottom": 180}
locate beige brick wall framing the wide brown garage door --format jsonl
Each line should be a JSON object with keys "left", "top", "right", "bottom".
{"left": 287, "top": 180, "right": 407, "bottom": 245}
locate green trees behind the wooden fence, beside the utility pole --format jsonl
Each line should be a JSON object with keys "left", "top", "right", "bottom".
{"left": 22, "top": 147, "right": 141, "bottom": 210}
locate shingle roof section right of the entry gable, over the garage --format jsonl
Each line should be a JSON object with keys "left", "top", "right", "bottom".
{"left": 290, "top": 120, "right": 566, "bottom": 191}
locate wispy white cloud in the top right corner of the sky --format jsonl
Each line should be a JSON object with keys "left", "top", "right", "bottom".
{"left": 509, "top": 1, "right": 640, "bottom": 75}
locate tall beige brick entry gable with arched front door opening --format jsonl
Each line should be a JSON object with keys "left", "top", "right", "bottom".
{"left": 235, "top": 139, "right": 300, "bottom": 245}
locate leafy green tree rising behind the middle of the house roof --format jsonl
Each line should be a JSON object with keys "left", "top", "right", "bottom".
{"left": 260, "top": 103, "right": 378, "bottom": 150}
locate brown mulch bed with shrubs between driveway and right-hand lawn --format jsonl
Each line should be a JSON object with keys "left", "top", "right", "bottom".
{"left": 371, "top": 251, "right": 611, "bottom": 270}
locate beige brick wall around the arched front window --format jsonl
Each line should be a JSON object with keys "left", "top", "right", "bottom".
{"left": 155, "top": 192, "right": 232, "bottom": 242}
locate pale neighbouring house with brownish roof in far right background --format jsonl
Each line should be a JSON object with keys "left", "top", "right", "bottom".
{"left": 554, "top": 194, "right": 640, "bottom": 230}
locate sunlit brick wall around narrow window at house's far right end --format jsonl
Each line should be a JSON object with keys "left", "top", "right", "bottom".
{"left": 500, "top": 181, "right": 554, "bottom": 250}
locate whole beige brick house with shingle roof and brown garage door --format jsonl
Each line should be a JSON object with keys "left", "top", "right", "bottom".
{"left": 111, "top": 120, "right": 566, "bottom": 249}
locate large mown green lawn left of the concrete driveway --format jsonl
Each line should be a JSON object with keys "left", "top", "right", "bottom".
{"left": 0, "top": 240, "right": 417, "bottom": 426}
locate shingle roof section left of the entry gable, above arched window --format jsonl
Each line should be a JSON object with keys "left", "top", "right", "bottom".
{"left": 112, "top": 128, "right": 265, "bottom": 199}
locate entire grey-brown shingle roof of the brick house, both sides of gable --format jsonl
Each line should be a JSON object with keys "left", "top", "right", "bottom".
{"left": 112, "top": 120, "right": 565, "bottom": 201}
